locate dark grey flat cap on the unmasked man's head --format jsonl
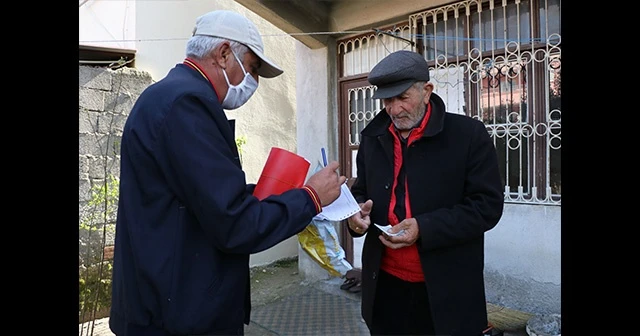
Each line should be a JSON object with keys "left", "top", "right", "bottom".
{"left": 368, "top": 50, "right": 429, "bottom": 99}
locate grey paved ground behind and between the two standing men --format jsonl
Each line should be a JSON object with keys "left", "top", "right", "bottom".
{"left": 79, "top": 259, "right": 531, "bottom": 336}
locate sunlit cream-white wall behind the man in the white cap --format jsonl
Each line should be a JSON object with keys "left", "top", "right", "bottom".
{"left": 79, "top": 0, "right": 300, "bottom": 266}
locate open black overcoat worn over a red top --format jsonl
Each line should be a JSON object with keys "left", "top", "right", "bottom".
{"left": 349, "top": 93, "right": 504, "bottom": 336}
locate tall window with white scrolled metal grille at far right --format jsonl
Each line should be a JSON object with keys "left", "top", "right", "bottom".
{"left": 409, "top": 0, "right": 561, "bottom": 205}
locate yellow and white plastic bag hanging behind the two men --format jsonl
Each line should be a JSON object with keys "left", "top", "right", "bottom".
{"left": 298, "top": 218, "right": 353, "bottom": 277}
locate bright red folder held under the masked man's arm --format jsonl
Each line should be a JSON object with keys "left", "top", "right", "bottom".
{"left": 253, "top": 147, "right": 311, "bottom": 200}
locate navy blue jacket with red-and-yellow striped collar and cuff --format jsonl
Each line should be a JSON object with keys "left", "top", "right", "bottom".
{"left": 109, "top": 64, "right": 316, "bottom": 336}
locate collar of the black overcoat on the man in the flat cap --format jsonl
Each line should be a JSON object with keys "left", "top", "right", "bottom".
{"left": 361, "top": 92, "right": 446, "bottom": 138}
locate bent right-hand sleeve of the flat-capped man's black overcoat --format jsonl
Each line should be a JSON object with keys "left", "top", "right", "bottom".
{"left": 416, "top": 121, "right": 504, "bottom": 249}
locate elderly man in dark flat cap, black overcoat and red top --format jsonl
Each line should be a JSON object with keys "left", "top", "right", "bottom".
{"left": 348, "top": 51, "right": 504, "bottom": 336}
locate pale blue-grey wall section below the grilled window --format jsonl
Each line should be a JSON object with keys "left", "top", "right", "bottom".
{"left": 485, "top": 204, "right": 562, "bottom": 314}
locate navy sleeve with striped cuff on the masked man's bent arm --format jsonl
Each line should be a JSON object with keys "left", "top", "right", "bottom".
{"left": 154, "top": 95, "right": 316, "bottom": 254}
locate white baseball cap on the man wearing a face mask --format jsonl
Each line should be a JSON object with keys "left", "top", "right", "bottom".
{"left": 193, "top": 10, "right": 283, "bottom": 78}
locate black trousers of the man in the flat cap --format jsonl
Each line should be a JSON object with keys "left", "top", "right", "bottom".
{"left": 369, "top": 270, "right": 435, "bottom": 335}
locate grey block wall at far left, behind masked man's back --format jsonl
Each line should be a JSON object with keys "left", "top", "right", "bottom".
{"left": 78, "top": 66, "right": 153, "bottom": 264}
